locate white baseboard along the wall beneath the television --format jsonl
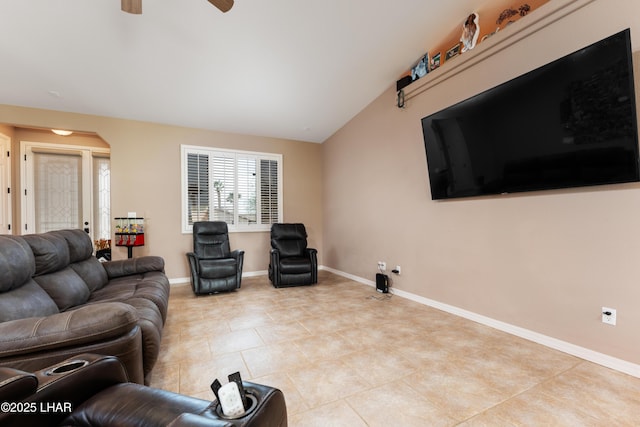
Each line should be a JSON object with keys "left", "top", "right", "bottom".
{"left": 321, "top": 267, "right": 640, "bottom": 378}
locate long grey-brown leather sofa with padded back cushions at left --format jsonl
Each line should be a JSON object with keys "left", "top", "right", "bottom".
{"left": 0, "top": 230, "right": 169, "bottom": 383}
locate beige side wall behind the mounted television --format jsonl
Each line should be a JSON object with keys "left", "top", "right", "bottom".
{"left": 323, "top": 0, "right": 640, "bottom": 364}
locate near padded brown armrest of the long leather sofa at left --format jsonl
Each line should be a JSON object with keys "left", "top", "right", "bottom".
{"left": 0, "top": 302, "right": 138, "bottom": 358}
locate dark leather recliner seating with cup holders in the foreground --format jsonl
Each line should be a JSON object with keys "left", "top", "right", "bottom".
{"left": 0, "top": 354, "right": 287, "bottom": 427}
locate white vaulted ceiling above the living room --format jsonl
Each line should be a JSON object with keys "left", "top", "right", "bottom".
{"left": 0, "top": 0, "right": 480, "bottom": 142}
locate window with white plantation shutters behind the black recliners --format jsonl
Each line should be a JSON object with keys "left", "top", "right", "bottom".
{"left": 182, "top": 145, "right": 282, "bottom": 233}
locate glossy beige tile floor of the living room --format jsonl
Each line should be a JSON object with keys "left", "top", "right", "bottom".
{"left": 151, "top": 271, "right": 640, "bottom": 427}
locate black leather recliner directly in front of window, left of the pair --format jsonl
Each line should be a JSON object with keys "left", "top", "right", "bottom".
{"left": 187, "top": 221, "right": 244, "bottom": 295}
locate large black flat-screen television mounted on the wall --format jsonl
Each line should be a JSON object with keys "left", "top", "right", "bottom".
{"left": 422, "top": 29, "right": 640, "bottom": 200}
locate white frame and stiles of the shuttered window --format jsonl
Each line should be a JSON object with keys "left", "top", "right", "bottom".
{"left": 180, "top": 144, "right": 283, "bottom": 234}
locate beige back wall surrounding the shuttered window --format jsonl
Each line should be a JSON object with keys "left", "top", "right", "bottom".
{"left": 0, "top": 105, "right": 322, "bottom": 279}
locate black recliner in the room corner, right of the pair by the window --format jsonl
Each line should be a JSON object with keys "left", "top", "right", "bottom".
{"left": 269, "top": 224, "right": 318, "bottom": 288}
